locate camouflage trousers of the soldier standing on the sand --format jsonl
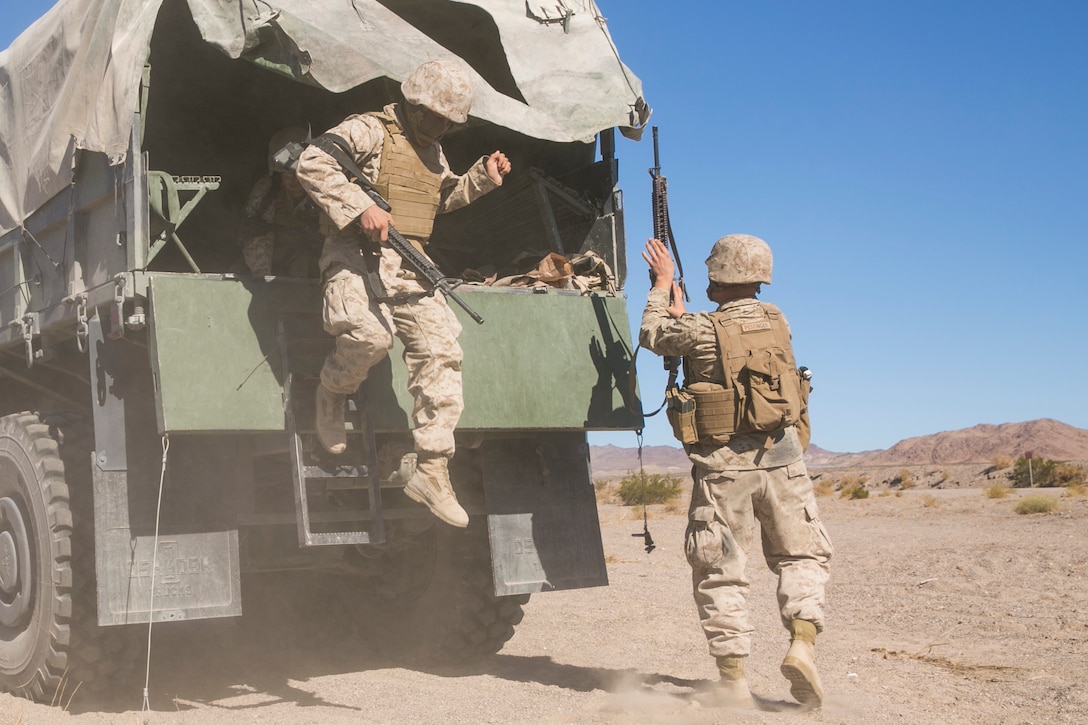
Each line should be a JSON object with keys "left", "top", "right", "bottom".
{"left": 684, "top": 462, "right": 833, "bottom": 656}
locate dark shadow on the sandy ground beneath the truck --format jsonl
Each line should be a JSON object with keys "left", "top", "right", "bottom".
{"left": 67, "top": 619, "right": 809, "bottom": 715}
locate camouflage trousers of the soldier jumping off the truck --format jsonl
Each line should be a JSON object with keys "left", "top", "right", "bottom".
{"left": 321, "top": 248, "right": 465, "bottom": 457}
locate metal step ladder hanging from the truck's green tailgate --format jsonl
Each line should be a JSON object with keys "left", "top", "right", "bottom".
{"left": 277, "top": 315, "right": 385, "bottom": 546}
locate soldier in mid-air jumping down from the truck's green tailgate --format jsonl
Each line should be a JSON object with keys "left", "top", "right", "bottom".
{"left": 297, "top": 61, "right": 510, "bottom": 527}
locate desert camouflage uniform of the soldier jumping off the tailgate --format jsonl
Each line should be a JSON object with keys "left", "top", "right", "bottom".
{"left": 297, "top": 105, "right": 497, "bottom": 457}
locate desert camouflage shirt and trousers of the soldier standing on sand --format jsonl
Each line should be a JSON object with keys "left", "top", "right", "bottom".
{"left": 639, "top": 288, "right": 833, "bottom": 658}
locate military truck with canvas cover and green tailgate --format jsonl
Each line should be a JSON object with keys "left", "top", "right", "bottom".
{"left": 0, "top": 0, "right": 648, "bottom": 701}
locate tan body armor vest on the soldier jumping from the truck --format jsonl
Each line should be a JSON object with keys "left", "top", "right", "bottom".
{"left": 370, "top": 113, "right": 442, "bottom": 239}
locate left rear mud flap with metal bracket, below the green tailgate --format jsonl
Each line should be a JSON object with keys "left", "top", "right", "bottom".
{"left": 88, "top": 318, "right": 242, "bottom": 626}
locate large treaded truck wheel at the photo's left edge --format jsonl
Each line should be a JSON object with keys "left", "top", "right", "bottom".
{"left": 0, "top": 413, "right": 72, "bottom": 700}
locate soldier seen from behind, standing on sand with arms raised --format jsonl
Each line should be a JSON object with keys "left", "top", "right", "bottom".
{"left": 639, "top": 234, "right": 833, "bottom": 708}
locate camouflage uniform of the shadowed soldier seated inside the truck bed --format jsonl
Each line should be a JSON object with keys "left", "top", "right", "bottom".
{"left": 238, "top": 173, "right": 322, "bottom": 277}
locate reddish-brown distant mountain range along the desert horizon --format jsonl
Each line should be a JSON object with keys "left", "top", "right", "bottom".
{"left": 590, "top": 418, "right": 1088, "bottom": 479}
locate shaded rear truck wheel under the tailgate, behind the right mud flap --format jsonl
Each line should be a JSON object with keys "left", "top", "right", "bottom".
{"left": 369, "top": 520, "right": 529, "bottom": 663}
